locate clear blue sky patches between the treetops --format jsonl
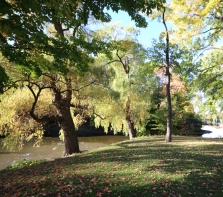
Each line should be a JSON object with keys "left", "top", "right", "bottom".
{"left": 109, "top": 11, "right": 165, "bottom": 48}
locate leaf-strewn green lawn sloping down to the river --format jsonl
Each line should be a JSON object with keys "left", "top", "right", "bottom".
{"left": 0, "top": 136, "right": 223, "bottom": 197}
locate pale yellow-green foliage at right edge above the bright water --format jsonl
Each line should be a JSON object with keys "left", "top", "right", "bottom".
{"left": 191, "top": 49, "right": 223, "bottom": 122}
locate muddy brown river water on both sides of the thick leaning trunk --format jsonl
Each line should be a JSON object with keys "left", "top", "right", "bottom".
{"left": 0, "top": 135, "right": 128, "bottom": 170}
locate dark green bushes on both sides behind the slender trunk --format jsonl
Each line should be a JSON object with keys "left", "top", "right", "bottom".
{"left": 142, "top": 91, "right": 195, "bottom": 136}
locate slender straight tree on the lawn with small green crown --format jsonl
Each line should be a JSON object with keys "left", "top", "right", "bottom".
{"left": 148, "top": 27, "right": 199, "bottom": 142}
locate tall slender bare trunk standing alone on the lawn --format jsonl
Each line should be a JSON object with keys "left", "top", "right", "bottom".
{"left": 163, "top": 8, "right": 172, "bottom": 142}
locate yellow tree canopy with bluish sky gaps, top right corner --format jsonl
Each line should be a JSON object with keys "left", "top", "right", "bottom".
{"left": 168, "top": 0, "right": 223, "bottom": 45}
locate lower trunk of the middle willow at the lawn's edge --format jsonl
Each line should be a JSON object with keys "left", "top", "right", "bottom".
{"left": 125, "top": 97, "right": 136, "bottom": 140}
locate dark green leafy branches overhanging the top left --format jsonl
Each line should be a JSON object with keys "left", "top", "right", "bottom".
{"left": 0, "top": 0, "right": 164, "bottom": 90}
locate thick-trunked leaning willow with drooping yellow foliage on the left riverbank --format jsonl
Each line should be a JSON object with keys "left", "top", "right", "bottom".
{"left": 0, "top": 62, "right": 93, "bottom": 154}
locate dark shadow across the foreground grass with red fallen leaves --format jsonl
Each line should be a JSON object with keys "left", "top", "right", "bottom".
{"left": 0, "top": 161, "right": 223, "bottom": 197}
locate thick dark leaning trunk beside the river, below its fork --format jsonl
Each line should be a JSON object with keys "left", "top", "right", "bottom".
{"left": 58, "top": 109, "right": 80, "bottom": 156}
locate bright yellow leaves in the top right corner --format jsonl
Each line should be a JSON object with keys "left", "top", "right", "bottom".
{"left": 169, "top": 0, "right": 223, "bottom": 43}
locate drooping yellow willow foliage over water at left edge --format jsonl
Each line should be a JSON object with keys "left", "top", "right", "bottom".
{"left": 0, "top": 88, "right": 49, "bottom": 151}
